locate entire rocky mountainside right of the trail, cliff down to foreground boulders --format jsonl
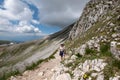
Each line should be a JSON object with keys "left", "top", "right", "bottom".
{"left": 44, "top": 0, "right": 120, "bottom": 80}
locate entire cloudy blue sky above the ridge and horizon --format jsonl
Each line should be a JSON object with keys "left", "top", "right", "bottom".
{"left": 0, "top": 0, "right": 88, "bottom": 41}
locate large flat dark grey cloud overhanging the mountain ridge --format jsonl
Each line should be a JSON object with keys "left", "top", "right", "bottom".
{"left": 28, "top": 0, "right": 89, "bottom": 27}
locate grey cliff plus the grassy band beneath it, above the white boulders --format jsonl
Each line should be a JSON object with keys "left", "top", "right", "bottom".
{"left": 69, "top": 0, "right": 120, "bottom": 58}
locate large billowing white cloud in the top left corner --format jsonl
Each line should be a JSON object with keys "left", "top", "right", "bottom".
{"left": 0, "top": 0, "right": 33, "bottom": 21}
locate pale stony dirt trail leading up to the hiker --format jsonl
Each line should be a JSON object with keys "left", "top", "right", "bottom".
{"left": 9, "top": 52, "right": 63, "bottom": 80}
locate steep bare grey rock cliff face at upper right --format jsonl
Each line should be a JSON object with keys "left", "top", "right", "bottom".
{"left": 69, "top": 0, "right": 120, "bottom": 39}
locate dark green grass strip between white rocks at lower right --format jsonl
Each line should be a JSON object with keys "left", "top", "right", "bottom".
{"left": 100, "top": 43, "right": 120, "bottom": 80}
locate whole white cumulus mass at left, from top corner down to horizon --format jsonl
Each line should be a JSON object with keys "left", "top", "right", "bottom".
{"left": 0, "top": 0, "right": 41, "bottom": 34}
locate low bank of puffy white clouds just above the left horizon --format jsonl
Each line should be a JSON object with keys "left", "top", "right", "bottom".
{"left": 0, "top": 18, "right": 42, "bottom": 34}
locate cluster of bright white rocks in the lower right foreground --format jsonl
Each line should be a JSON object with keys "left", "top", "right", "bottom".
{"left": 73, "top": 59, "right": 107, "bottom": 80}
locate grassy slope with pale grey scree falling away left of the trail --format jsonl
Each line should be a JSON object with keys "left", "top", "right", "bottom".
{"left": 0, "top": 25, "right": 72, "bottom": 80}
